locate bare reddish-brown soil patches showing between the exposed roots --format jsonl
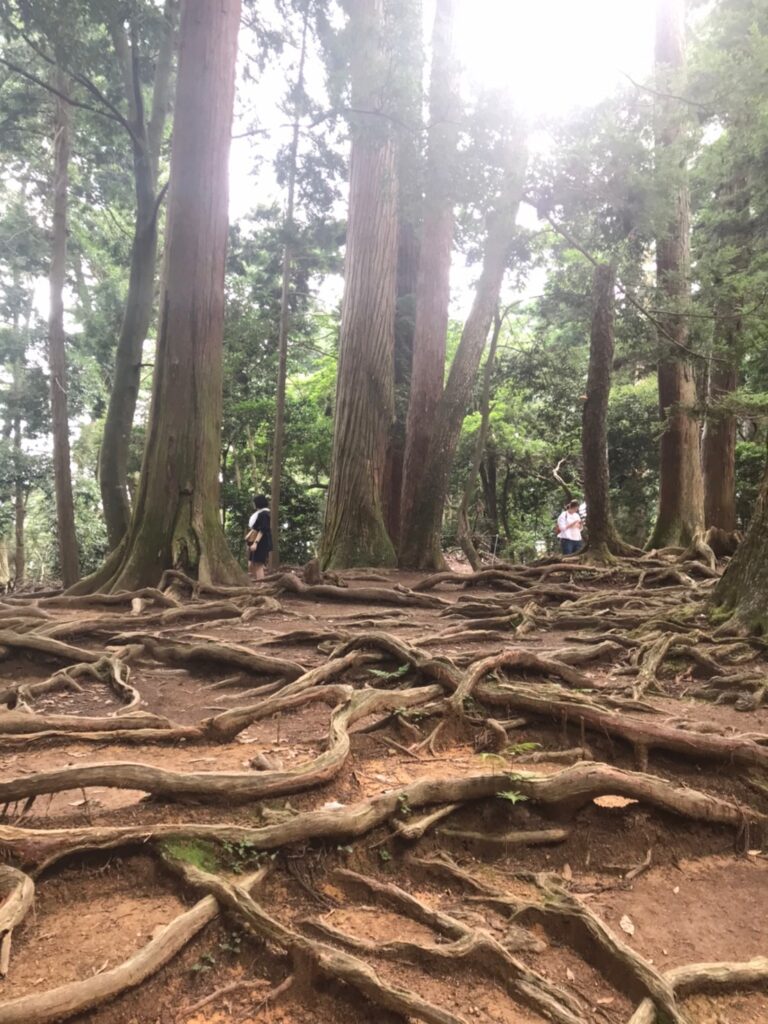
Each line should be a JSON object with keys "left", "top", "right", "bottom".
{"left": 0, "top": 573, "right": 768, "bottom": 1024}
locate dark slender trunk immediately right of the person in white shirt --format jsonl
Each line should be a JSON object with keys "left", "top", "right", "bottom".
{"left": 582, "top": 263, "right": 630, "bottom": 561}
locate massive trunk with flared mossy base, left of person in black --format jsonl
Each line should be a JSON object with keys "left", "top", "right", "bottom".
{"left": 71, "top": 0, "right": 244, "bottom": 592}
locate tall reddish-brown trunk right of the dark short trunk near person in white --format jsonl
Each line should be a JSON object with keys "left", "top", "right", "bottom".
{"left": 649, "top": 0, "right": 705, "bottom": 548}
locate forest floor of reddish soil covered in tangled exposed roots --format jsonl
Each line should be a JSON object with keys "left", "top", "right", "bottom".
{"left": 0, "top": 557, "right": 768, "bottom": 1024}
